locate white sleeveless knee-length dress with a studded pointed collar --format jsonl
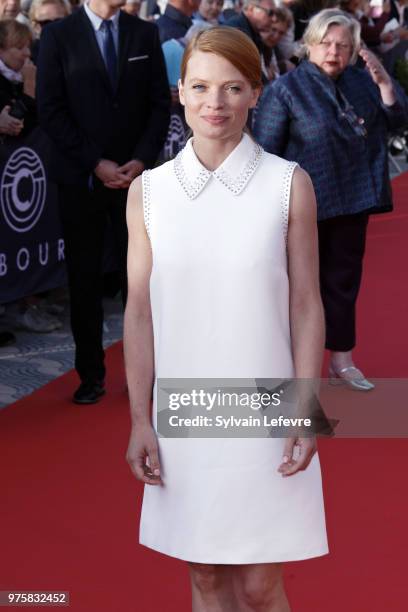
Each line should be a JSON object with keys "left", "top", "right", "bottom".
{"left": 140, "top": 134, "right": 328, "bottom": 564}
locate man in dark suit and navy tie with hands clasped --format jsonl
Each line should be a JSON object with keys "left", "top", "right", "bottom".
{"left": 37, "top": 0, "right": 170, "bottom": 404}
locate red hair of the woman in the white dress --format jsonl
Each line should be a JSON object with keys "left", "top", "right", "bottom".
{"left": 181, "top": 26, "right": 262, "bottom": 89}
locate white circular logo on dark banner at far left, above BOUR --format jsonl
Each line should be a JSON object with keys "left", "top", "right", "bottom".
{"left": 0, "top": 147, "right": 47, "bottom": 232}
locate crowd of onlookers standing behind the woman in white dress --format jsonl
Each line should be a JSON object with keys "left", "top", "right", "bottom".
{"left": 0, "top": 0, "right": 408, "bottom": 403}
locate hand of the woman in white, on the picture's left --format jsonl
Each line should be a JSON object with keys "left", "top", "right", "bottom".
{"left": 126, "top": 422, "right": 163, "bottom": 485}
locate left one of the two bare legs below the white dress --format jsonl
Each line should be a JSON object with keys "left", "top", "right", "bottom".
{"left": 188, "top": 563, "right": 238, "bottom": 612}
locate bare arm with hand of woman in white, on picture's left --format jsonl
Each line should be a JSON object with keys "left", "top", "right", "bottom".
{"left": 124, "top": 177, "right": 161, "bottom": 485}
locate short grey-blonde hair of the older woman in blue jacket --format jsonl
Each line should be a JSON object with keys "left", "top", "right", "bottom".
{"left": 300, "top": 9, "right": 361, "bottom": 64}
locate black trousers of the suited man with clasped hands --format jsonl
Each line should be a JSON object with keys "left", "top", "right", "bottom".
{"left": 59, "top": 179, "right": 128, "bottom": 381}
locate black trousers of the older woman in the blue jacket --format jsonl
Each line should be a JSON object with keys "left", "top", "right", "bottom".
{"left": 318, "top": 213, "right": 368, "bottom": 351}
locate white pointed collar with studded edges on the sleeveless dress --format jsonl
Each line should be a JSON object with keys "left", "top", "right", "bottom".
{"left": 173, "top": 133, "right": 263, "bottom": 200}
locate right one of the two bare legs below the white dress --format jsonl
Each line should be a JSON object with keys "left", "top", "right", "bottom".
{"left": 230, "top": 563, "right": 290, "bottom": 612}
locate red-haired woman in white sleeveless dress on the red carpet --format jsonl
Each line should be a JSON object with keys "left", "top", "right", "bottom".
{"left": 125, "top": 27, "right": 327, "bottom": 612}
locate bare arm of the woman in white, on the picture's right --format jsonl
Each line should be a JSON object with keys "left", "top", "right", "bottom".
{"left": 278, "top": 168, "right": 325, "bottom": 476}
